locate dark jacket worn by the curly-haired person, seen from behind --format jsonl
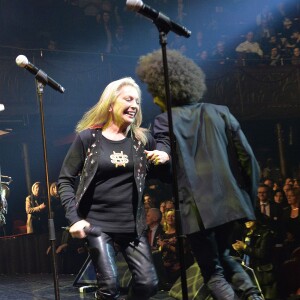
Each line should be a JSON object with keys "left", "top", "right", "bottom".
{"left": 154, "top": 103, "right": 259, "bottom": 234}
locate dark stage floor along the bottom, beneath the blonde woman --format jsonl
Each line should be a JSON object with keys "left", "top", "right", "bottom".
{"left": 0, "top": 274, "right": 174, "bottom": 300}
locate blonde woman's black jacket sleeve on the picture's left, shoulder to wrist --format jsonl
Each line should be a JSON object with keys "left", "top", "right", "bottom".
{"left": 58, "top": 135, "right": 85, "bottom": 225}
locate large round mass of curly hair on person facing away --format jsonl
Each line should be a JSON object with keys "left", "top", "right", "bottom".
{"left": 136, "top": 50, "right": 206, "bottom": 106}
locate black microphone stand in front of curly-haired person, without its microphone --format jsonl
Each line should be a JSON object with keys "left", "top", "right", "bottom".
{"left": 153, "top": 21, "right": 188, "bottom": 300}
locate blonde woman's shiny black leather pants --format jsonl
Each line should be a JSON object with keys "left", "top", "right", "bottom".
{"left": 87, "top": 233, "right": 158, "bottom": 300}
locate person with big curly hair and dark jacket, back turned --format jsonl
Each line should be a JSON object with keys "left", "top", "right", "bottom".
{"left": 136, "top": 50, "right": 262, "bottom": 300}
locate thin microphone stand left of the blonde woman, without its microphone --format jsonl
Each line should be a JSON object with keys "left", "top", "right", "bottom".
{"left": 36, "top": 78, "right": 60, "bottom": 300}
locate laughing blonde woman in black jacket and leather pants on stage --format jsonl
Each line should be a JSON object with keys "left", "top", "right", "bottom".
{"left": 58, "top": 77, "right": 169, "bottom": 300}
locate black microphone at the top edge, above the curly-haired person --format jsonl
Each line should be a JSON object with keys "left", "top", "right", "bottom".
{"left": 126, "top": 0, "right": 191, "bottom": 38}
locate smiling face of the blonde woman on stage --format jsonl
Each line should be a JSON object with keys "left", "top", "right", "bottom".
{"left": 110, "top": 85, "right": 140, "bottom": 127}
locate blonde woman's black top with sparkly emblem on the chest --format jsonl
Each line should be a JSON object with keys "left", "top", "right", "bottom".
{"left": 86, "top": 135, "right": 137, "bottom": 233}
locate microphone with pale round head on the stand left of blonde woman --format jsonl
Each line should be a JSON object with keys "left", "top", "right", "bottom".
{"left": 16, "top": 55, "right": 65, "bottom": 93}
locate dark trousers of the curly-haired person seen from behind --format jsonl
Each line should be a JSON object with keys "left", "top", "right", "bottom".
{"left": 187, "top": 222, "right": 260, "bottom": 300}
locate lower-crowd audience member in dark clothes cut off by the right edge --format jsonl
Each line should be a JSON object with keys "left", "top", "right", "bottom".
{"left": 282, "top": 188, "right": 300, "bottom": 259}
